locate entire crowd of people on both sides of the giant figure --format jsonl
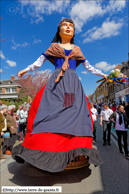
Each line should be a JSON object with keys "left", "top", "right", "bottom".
{"left": 0, "top": 100, "right": 129, "bottom": 159}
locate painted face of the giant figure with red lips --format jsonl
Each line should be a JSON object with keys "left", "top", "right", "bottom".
{"left": 59, "top": 21, "right": 74, "bottom": 40}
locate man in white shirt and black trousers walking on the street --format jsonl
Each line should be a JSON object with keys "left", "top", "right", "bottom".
{"left": 100, "top": 103, "right": 113, "bottom": 146}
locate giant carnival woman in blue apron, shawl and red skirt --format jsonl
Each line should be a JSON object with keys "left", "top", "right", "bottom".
{"left": 12, "top": 18, "right": 107, "bottom": 172}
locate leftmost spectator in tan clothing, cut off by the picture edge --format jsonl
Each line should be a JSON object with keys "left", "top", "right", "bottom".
{"left": 0, "top": 105, "right": 11, "bottom": 159}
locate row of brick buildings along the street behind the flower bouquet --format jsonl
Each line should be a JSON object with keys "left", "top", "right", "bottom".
{"left": 91, "top": 60, "right": 129, "bottom": 105}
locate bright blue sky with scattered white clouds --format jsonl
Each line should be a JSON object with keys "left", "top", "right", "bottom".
{"left": 0, "top": 0, "right": 129, "bottom": 96}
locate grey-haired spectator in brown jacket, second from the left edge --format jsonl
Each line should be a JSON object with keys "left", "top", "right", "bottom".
{"left": 3, "top": 105, "right": 18, "bottom": 155}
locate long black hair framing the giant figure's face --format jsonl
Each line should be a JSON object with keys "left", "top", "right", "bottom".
{"left": 52, "top": 18, "right": 75, "bottom": 44}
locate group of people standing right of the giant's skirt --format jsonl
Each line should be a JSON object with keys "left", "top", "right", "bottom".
{"left": 90, "top": 101, "right": 129, "bottom": 159}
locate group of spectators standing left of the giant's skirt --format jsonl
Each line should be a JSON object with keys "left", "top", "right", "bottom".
{"left": 0, "top": 100, "right": 32, "bottom": 159}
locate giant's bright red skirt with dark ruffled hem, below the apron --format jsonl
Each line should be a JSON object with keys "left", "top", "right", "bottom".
{"left": 12, "top": 86, "right": 102, "bottom": 172}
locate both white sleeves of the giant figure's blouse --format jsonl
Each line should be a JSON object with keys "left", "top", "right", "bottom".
{"left": 25, "top": 55, "right": 103, "bottom": 77}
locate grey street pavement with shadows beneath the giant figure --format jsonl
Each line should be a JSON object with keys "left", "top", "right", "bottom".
{"left": 0, "top": 120, "right": 129, "bottom": 194}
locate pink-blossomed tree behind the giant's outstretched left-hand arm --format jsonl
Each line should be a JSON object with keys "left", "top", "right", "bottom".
{"left": 15, "top": 70, "right": 52, "bottom": 99}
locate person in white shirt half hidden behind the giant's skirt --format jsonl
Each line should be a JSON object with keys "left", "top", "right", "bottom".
{"left": 90, "top": 102, "right": 98, "bottom": 142}
